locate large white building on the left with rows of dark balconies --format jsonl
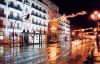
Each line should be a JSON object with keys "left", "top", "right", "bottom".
{"left": 0, "top": 0, "right": 48, "bottom": 43}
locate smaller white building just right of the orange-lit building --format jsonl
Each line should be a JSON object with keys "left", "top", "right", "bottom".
{"left": 59, "top": 16, "right": 70, "bottom": 46}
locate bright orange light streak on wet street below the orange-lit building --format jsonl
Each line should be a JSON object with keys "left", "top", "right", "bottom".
{"left": 48, "top": 44, "right": 61, "bottom": 64}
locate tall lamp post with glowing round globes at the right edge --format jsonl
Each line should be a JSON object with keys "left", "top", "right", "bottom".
{"left": 91, "top": 11, "right": 100, "bottom": 48}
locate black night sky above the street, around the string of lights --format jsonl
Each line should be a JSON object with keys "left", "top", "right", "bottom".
{"left": 51, "top": 0, "right": 100, "bottom": 28}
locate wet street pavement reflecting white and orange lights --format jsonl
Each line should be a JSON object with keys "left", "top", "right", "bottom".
{"left": 0, "top": 41, "right": 96, "bottom": 64}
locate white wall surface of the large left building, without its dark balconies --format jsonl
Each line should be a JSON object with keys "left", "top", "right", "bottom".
{"left": 0, "top": 0, "right": 48, "bottom": 43}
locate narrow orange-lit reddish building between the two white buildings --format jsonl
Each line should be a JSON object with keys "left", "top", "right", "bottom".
{"left": 42, "top": 0, "right": 59, "bottom": 43}
